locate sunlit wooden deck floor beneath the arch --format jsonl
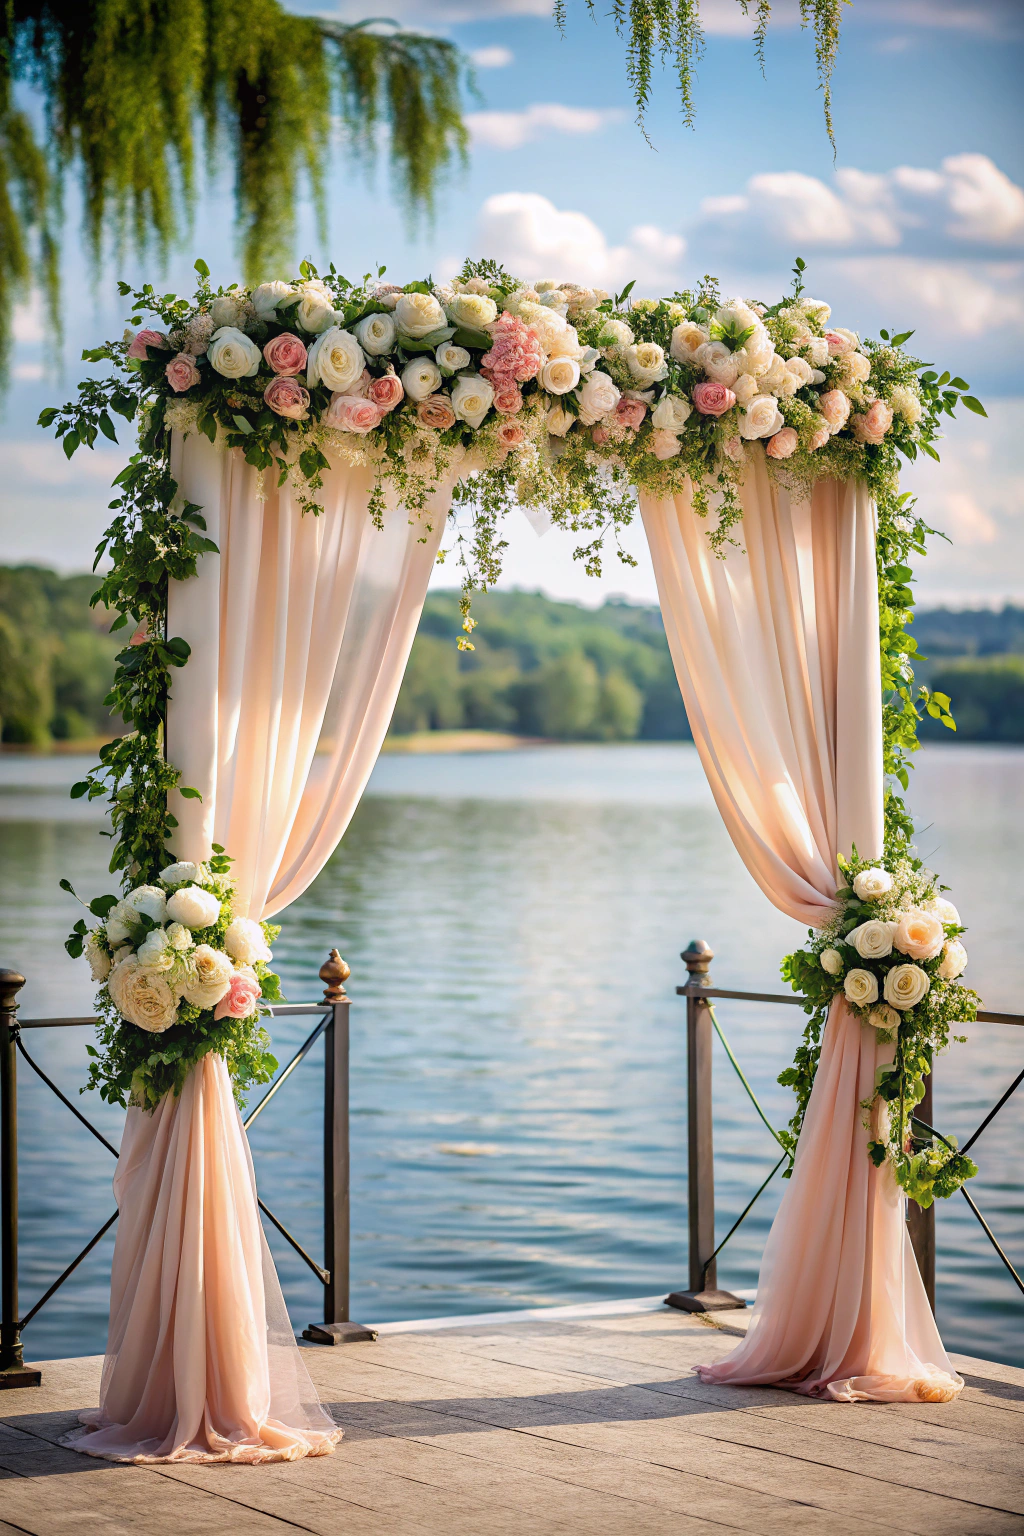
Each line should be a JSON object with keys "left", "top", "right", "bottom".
{"left": 0, "top": 1309, "right": 1024, "bottom": 1536}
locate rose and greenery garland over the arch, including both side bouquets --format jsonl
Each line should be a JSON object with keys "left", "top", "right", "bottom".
{"left": 40, "top": 251, "right": 984, "bottom": 1204}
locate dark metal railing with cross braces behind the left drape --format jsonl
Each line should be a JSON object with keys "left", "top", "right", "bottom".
{"left": 0, "top": 949, "right": 376, "bottom": 1389}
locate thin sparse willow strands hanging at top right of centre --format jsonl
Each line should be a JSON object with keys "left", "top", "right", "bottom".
{"left": 554, "top": 0, "right": 852, "bottom": 151}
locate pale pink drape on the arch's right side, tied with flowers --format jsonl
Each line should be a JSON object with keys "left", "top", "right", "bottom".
{"left": 640, "top": 450, "right": 963, "bottom": 1401}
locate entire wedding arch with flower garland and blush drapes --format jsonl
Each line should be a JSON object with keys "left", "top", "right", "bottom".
{"left": 40, "top": 260, "right": 983, "bottom": 1461}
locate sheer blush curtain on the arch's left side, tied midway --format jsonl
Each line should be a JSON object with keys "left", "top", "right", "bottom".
{"left": 74, "top": 435, "right": 450, "bottom": 1461}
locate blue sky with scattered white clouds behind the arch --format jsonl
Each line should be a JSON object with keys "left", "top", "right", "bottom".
{"left": 0, "top": 0, "right": 1024, "bottom": 602}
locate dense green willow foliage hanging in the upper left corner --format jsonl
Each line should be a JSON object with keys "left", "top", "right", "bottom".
{"left": 0, "top": 0, "right": 468, "bottom": 384}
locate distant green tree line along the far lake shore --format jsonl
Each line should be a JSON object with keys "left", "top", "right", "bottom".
{"left": 0, "top": 565, "right": 1024, "bottom": 748}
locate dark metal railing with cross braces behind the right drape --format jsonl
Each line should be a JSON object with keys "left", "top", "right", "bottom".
{"left": 665, "top": 938, "right": 1024, "bottom": 1312}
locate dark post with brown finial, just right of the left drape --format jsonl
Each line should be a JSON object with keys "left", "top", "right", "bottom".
{"left": 302, "top": 949, "right": 376, "bottom": 1344}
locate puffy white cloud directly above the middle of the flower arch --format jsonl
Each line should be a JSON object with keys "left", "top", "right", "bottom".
{"left": 476, "top": 192, "right": 686, "bottom": 289}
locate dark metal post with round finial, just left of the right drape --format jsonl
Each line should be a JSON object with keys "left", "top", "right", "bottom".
{"left": 665, "top": 938, "right": 746, "bottom": 1312}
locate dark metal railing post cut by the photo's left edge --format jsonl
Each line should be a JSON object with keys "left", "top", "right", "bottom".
{"left": 0, "top": 969, "right": 41, "bottom": 1387}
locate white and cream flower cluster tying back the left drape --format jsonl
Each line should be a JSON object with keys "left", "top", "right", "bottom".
{"left": 84, "top": 862, "right": 273, "bottom": 1034}
